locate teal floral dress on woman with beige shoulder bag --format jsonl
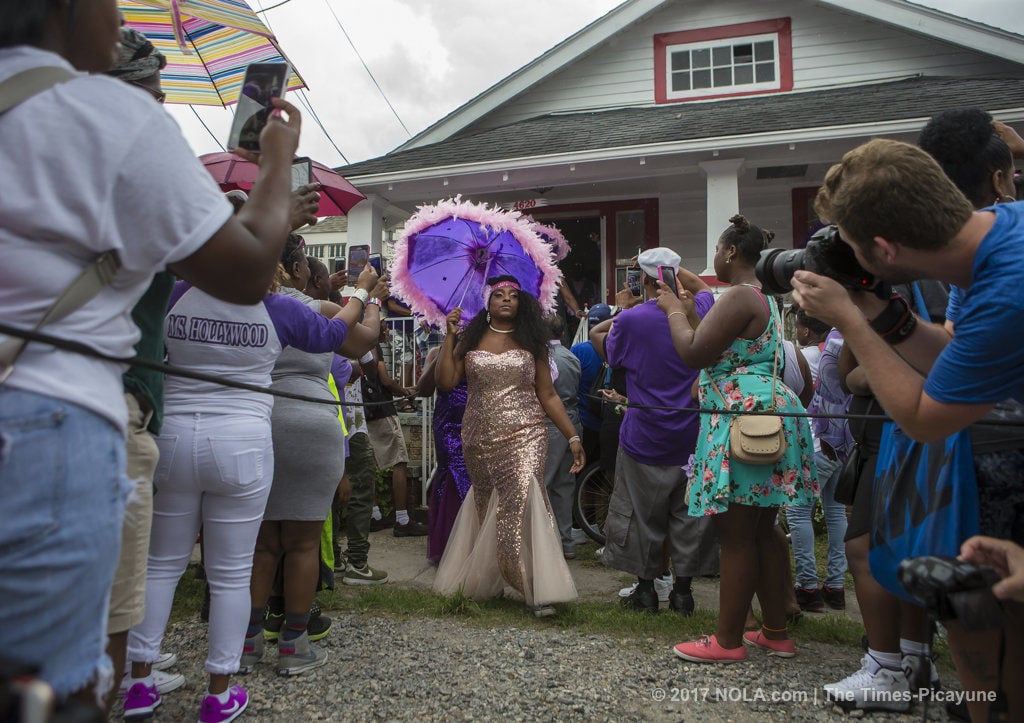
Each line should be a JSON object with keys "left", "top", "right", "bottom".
{"left": 689, "top": 292, "right": 819, "bottom": 517}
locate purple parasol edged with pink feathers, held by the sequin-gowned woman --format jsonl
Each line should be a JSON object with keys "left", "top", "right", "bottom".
{"left": 391, "top": 198, "right": 561, "bottom": 327}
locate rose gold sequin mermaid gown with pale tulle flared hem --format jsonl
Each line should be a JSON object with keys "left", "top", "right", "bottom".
{"left": 434, "top": 349, "right": 577, "bottom": 605}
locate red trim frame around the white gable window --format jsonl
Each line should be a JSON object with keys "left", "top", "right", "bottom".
{"left": 654, "top": 17, "right": 793, "bottom": 103}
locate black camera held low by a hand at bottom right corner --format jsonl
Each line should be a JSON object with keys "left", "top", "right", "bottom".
{"left": 897, "top": 555, "right": 1005, "bottom": 630}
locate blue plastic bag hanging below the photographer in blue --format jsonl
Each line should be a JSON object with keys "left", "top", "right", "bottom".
{"left": 867, "top": 422, "right": 979, "bottom": 602}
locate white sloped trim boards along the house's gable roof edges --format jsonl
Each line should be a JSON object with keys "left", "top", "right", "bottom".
{"left": 396, "top": 0, "right": 1024, "bottom": 152}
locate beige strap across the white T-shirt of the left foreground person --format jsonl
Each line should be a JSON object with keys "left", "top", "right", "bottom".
{"left": 0, "top": 66, "right": 121, "bottom": 384}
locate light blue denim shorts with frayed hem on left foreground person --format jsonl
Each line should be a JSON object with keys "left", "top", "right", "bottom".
{"left": 0, "top": 388, "right": 130, "bottom": 697}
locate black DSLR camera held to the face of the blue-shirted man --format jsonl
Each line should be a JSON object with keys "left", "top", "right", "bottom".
{"left": 754, "top": 226, "right": 892, "bottom": 299}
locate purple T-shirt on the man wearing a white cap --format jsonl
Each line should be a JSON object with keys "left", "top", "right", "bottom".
{"left": 604, "top": 291, "right": 715, "bottom": 466}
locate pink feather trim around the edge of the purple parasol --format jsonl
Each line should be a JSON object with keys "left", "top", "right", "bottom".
{"left": 391, "top": 196, "right": 562, "bottom": 328}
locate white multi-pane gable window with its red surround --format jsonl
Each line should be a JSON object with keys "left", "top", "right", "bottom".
{"left": 654, "top": 18, "right": 793, "bottom": 103}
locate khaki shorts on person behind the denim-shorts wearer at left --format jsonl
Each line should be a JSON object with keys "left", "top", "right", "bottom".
{"left": 106, "top": 394, "right": 160, "bottom": 634}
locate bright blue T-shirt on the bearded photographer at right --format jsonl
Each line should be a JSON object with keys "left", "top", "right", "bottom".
{"left": 925, "top": 202, "right": 1024, "bottom": 403}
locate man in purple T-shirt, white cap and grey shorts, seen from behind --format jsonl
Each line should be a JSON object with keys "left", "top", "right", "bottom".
{"left": 591, "top": 247, "right": 718, "bottom": 615}
